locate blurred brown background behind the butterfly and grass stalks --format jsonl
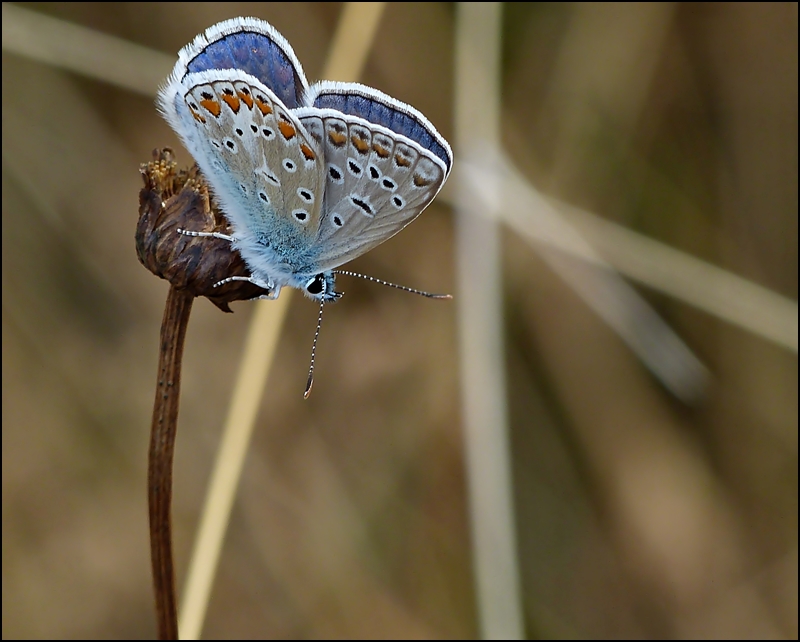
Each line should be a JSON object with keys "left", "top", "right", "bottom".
{"left": 2, "top": 3, "right": 798, "bottom": 638}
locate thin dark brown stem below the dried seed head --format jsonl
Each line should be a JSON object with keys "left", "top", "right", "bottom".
{"left": 147, "top": 286, "right": 194, "bottom": 640}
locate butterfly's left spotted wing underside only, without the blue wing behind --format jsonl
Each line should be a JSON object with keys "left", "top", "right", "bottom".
{"left": 159, "top": 69, "right": 325, "bottom": 242}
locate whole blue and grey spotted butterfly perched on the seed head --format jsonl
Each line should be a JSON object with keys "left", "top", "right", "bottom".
{"left": 158, "top": 18, "right": 452, "bottom": 301}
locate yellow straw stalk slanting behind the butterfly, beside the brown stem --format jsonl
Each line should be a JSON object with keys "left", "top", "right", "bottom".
{"left": 178, "top": 2, "right": 384, "bottom": 640}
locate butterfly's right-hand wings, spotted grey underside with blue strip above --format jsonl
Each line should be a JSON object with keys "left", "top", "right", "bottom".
{"left": 295, "top": 82, "right": 452, "bottom": 271}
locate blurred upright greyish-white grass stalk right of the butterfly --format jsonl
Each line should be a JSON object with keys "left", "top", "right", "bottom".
{"left": 455, "top": 2, "right": 524, "bottom": 639}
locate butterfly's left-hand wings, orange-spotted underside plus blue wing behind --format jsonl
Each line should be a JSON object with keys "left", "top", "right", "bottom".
{"left": 158, "top": 19, "right": 325, "bottom": 282}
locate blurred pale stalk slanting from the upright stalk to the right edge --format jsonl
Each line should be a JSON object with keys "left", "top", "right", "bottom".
{"left": 439, "top": 155, "right": 798, "bottom": 354}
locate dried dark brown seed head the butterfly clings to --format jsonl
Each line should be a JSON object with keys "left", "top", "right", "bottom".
{"left": 136, "top": 148, "right": 264, "bottom": 312}
